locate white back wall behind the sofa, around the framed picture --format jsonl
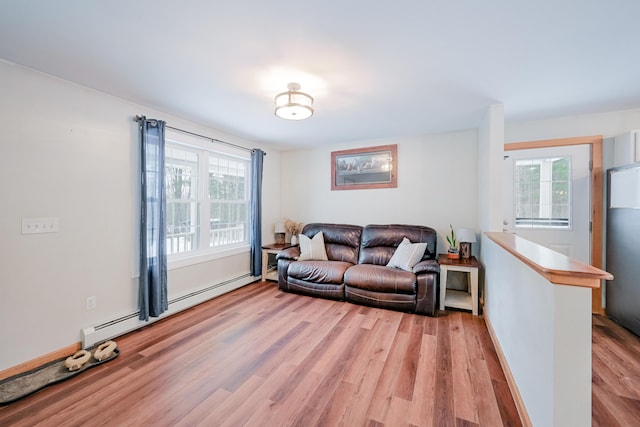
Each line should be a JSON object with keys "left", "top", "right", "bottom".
{"left": 281, "top": 130, "right": 478, "bottom": 251}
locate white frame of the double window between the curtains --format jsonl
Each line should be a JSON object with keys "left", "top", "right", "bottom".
{"left": 165, "top": 129, "right": 251, "bottom": 269}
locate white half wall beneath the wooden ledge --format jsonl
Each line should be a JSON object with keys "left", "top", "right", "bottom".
{"left": 482, "top": 236, "right": 591, "bottom": 426}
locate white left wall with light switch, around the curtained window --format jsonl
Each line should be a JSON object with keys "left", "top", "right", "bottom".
{"left": 0, "top": 61, "right": 280, "bottom": 370}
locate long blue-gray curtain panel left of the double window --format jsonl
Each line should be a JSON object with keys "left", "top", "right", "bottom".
{"left": 138, "top": 116, "right": 169, "bottom": 320}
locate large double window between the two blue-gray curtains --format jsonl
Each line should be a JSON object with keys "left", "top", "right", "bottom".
{"left": 165, "top": 132, "right": 250, "bottom": 259}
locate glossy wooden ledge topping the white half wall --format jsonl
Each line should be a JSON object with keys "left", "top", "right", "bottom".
{"left": 484, "top": 232, "right": 613, "bottom": 289}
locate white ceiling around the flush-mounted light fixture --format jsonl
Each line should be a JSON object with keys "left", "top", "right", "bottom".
{"left": 0, "top": 0, "right": 640, "bottom": 148}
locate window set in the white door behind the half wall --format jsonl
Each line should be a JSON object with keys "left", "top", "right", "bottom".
{"left": 513, "top": 157, "right": 571, "bottom": 228}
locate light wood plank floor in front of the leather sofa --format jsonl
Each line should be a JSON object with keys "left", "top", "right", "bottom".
{"left": 0, "top": 282, "right": 520, "bottom": 427}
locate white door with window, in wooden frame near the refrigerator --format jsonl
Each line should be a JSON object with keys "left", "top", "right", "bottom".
{"left": 503, "top": 145, "right": 591, "bottom": 264}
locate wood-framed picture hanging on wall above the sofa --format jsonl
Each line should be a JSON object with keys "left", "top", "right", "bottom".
{"left": 331, "top": 144, "right": 398, "bottom": 191}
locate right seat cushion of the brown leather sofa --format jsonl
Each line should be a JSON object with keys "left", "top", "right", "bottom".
{"left": 344, "top": 264, "right": 416, "bottom": 294}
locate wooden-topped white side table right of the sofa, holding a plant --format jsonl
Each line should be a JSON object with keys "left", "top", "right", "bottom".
{"left": 438, "top": 254, "right": 480, "bottom": 316}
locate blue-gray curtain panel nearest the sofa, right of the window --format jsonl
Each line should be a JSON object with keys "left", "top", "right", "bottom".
{"left": 249, "top": 148, "right": 265, "bottom": 276}
